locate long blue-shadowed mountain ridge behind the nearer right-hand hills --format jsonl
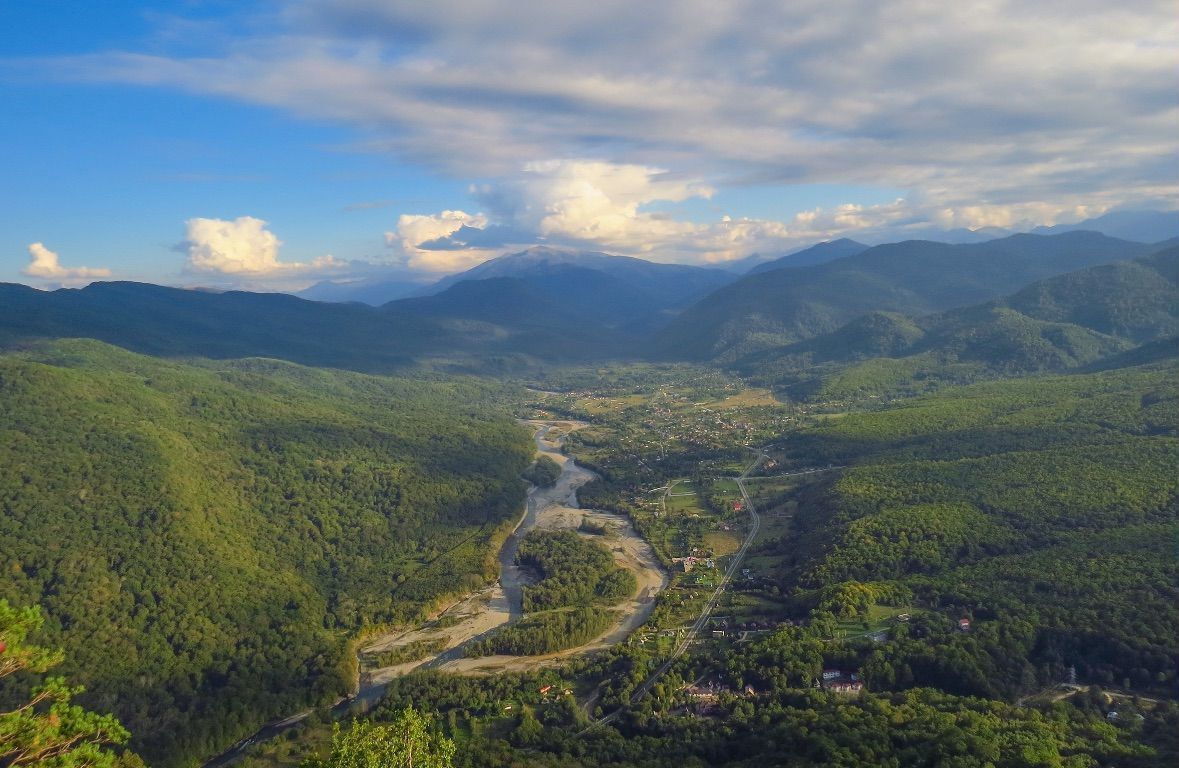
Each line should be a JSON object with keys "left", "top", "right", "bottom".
{"left": 652, "top": 232, "right": 1150, "bottom": 363}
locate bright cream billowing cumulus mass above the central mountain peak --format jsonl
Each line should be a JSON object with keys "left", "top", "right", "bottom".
{"left": 396, "top": 160, "right": 914, "bottom": 271}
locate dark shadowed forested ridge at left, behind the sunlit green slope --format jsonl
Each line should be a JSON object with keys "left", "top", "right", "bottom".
{"left": 0, "top": 281, "right": 620, "bottom": 373}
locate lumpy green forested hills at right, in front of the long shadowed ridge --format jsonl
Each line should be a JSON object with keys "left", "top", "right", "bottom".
{"left": 735, "top": 248, "right": 1179, "bottom": 400}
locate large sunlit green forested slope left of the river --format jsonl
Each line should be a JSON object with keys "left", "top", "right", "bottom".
{"left": 0, "top": 341, "right": 532, "bottom": 764}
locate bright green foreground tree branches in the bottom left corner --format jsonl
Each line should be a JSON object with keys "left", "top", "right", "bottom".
{"left": 0, "top": 599, "right": 143, "bottom": 768}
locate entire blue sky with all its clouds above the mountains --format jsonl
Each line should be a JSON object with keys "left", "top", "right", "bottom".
{"left": 0, "top": 0, "right": 1179, "bottom": 290}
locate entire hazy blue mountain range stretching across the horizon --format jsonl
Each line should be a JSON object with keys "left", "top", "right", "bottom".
{"left": 0, "top": 231, "right": 1173, "bottom": 382}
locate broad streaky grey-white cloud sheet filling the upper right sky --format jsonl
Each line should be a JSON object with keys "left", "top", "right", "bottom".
{"left": 36, "top": 0, "right": 1179, "bottom": 218}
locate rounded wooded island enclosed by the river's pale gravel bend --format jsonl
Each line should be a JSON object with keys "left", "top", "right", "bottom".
{"left": 516, "top": 531, "right": 638, "bottom": 612}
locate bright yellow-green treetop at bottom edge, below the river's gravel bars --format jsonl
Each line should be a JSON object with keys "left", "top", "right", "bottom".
{"left": 303, "top": 707, "right": 454, "bottom": 768}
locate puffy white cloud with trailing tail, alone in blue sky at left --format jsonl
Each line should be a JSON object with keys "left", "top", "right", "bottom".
{"left": 184, "top": 216, "right": 345, "bottom": 277}
